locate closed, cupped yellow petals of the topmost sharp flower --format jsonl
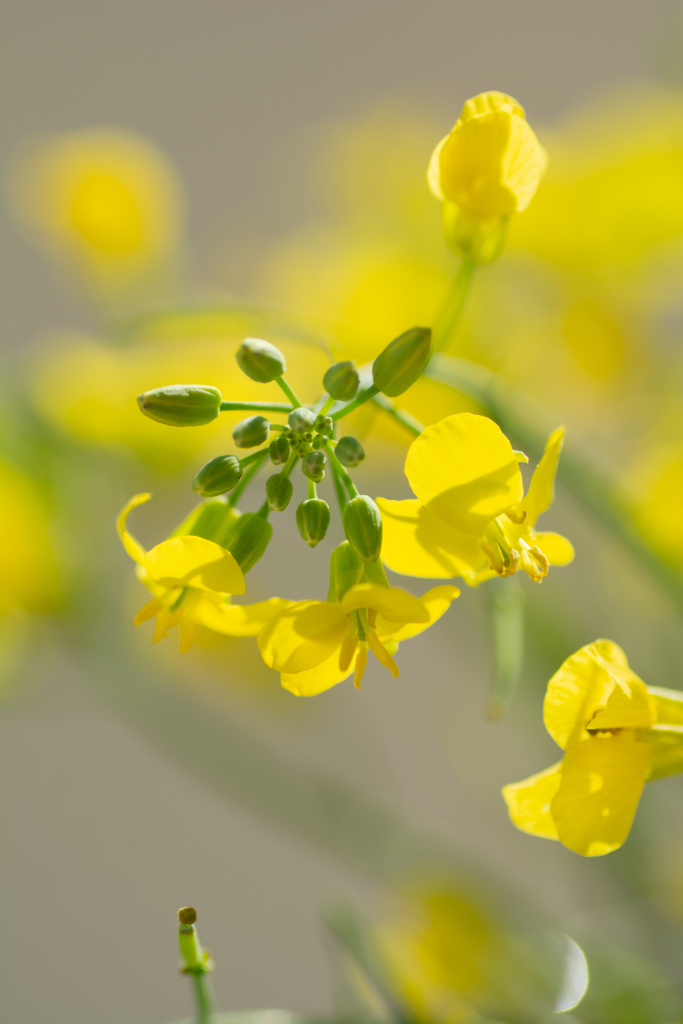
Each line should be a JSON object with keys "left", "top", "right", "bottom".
{"left": 427, "top": 92, "right": 547, "bottom": 220}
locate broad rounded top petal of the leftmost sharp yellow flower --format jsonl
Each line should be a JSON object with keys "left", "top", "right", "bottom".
{"left": 143, "top": 535, "right": 245, "bottom": 594}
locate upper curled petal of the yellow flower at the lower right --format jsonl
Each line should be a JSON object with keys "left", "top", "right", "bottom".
{"left": 543, "top": 640, "right": 638, "bottom": 750}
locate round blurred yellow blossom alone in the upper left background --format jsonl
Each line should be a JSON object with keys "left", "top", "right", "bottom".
{"left": 11, "top": 128, "right": 182, "bottom": 284}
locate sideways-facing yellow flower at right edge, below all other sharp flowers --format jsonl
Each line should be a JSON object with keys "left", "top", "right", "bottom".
{"left": 503, "top": 640, "right": 683, "bottom": 857}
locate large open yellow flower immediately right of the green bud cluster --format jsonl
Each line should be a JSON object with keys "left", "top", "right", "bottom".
{"left": 377, "top": 413, "right": 573, "bottom": 586}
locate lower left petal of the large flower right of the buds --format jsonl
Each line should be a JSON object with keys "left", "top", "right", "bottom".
{"left": 377, "top": 498, "right": 486, "bottom": 583}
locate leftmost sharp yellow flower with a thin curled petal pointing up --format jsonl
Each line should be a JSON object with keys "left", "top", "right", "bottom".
{"left": 117, "top": 495, "right": 289, "bottom": 653}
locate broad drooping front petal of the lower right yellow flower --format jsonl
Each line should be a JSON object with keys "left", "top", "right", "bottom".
{"left": 551, "top": 732, "right": 651, "bottom": 857}
